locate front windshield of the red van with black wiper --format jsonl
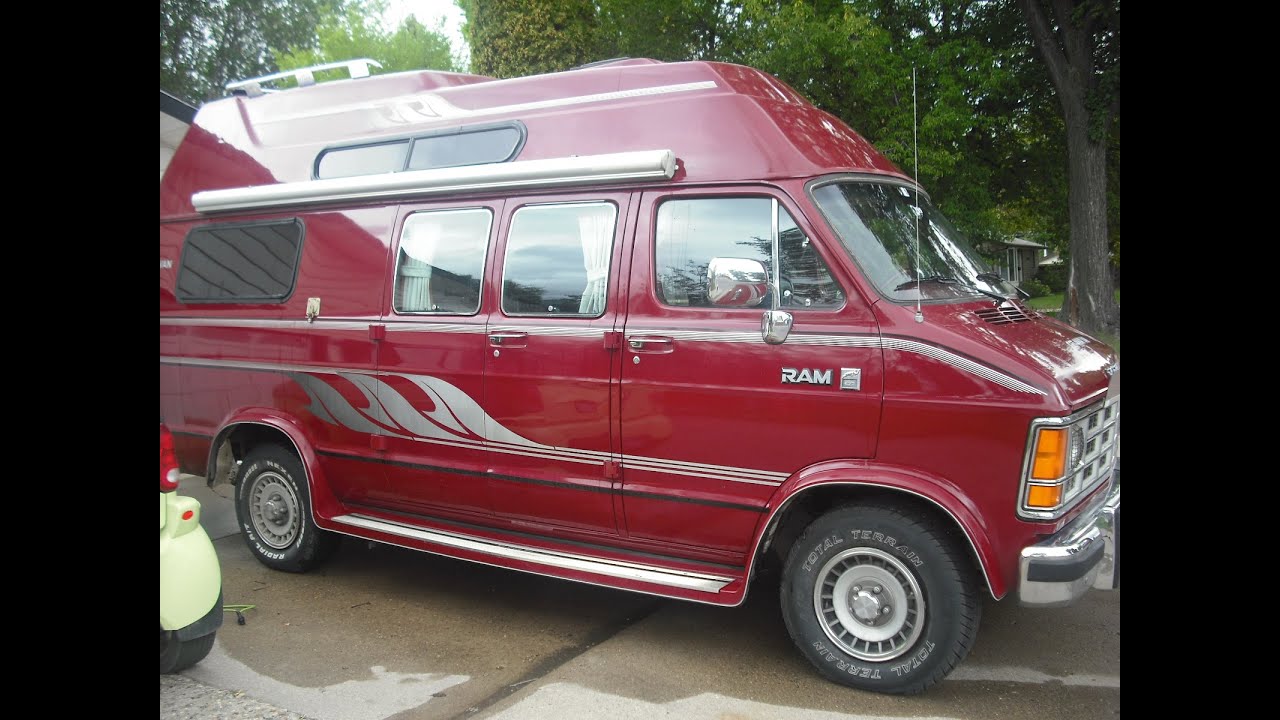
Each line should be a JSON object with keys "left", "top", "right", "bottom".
{"left": 813, "top": 181, "right": 1018, "bottom": 302}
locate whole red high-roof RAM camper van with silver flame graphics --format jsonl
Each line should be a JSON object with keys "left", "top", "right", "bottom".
{"left": 160, "top": 59, "right": 1120, "bottom": 693}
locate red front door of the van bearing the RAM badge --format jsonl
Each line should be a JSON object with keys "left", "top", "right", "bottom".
{"left": 620, "top": 187, "right": 883, "bottom": 559}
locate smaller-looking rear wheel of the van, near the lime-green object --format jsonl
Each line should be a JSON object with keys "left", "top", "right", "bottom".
{"left": 236, "top": 445, "right": 340, "bottom": 573}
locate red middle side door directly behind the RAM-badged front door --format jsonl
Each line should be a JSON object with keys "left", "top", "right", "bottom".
{"left": 484, "top": 192, "right": 630, "bottom": 536}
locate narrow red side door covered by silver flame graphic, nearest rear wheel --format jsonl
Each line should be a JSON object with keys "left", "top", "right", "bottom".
{"left": 369, "top": 201, "right": 502, "bottom": 520}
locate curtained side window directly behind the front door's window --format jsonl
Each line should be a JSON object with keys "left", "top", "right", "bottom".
{"left": 502, "top": 202, "right": 618, "bottom": 318}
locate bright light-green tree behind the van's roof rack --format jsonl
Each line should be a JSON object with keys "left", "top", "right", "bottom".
{"left": 276, "top": 0, "right": 461, "bottom": 74}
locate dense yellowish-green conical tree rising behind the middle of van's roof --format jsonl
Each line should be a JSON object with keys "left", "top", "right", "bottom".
{"left": 458, "top": 0, "right": 603, "bottom": 78}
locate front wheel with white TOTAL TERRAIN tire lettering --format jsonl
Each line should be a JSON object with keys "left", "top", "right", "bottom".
{"left": 781, "top": 505, "right": 982, "bottom": 694}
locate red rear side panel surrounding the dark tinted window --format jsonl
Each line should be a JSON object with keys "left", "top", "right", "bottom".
{"left": 160, "top": 205, "right": 394, "bottom": 498}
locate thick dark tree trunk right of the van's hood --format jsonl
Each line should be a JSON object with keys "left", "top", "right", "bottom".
{"left": 1020, "top": 0, "right": 1120, "bottom": 333}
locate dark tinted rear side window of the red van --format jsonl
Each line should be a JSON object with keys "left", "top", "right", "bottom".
{"left": 177, "top": 219, "right": 302, "bottom": 302}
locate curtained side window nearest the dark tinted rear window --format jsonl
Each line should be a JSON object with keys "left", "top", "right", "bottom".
{"left": 392, "top": 208, "right": 493, "bottom": 315}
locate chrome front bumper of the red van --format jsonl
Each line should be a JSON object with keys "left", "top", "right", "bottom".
{"left": 1018, "top": 461, "right": 1120, "bottom": 607}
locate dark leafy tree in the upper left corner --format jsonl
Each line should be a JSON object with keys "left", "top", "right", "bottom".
{"left": 160, "top": 0, "right": 344, "bottom": 105}
